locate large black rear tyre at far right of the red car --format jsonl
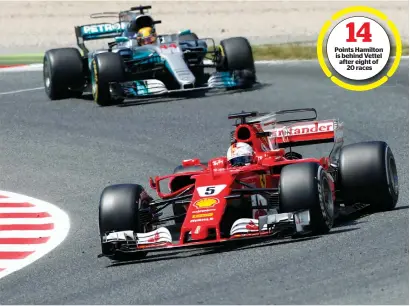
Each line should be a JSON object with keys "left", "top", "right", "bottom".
{"left": 338, "top": 141, "right": 399, "bottom": 211}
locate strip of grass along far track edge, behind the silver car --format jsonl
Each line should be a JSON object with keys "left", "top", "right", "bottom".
{"left": 0, "top": 43, "right": 409, "bottom": 65}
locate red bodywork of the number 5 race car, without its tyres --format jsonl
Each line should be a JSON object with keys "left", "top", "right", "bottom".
{"left": 137, "top": 112, "right": 343, "bottom": 248}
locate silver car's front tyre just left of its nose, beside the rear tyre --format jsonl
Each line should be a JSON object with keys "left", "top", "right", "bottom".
{"left": 91, "top": 52, "right": 125, "bottom": 106}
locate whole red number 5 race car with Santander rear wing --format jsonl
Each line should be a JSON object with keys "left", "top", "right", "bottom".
{"left": 99, "top": 109, "right": 399, "bottom": 260}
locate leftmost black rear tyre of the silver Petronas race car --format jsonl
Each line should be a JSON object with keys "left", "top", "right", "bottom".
{"left": 43, "top": 48, "right": 85, "bottom": 100}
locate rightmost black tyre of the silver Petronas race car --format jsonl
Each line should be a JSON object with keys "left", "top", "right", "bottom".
{"left": 217, "top": 37, "right": 256, "bottom": 88}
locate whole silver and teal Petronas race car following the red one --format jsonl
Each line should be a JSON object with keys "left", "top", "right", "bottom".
{"left": 43, "top": 6, "right": 256, "bottom": 106}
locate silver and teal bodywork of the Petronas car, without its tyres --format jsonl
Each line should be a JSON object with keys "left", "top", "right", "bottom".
{"left": 75, "top": 10, "right": 256, "bottom": 101}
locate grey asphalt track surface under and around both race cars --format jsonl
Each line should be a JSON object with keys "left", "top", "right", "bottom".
{"left": 0, "top": 61, "right": 409, "bottom": 304}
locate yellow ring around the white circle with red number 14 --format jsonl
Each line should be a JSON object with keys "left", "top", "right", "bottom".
{"left": 316, "top": 6, "right": 402, "bottom": 91}
